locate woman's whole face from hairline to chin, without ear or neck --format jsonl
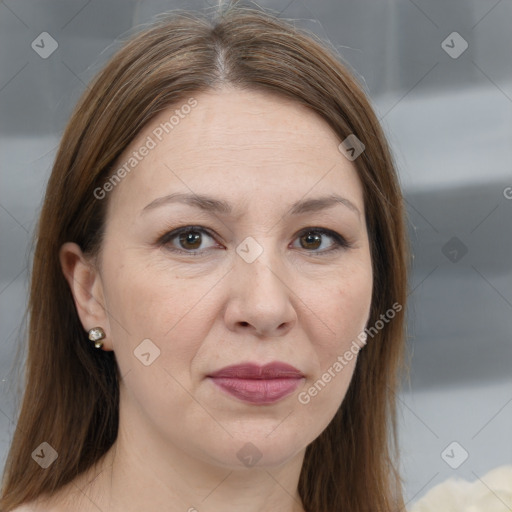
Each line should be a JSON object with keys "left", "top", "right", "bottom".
{"left": 85, "top": 89, "right": 372, "bottom": 468}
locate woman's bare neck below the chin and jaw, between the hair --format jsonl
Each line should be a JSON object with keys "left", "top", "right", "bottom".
{"left": 59, "top": 404, "right": 305, "bottom": 512}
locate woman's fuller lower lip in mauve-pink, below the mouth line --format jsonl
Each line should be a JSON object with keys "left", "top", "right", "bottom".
{"left": 211, "top": 377, "right": 303, "bottom": 405}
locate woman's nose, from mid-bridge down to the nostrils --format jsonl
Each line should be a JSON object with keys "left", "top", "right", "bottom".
{"left": 224, "top": 255, "right": 297, "bottom": 337}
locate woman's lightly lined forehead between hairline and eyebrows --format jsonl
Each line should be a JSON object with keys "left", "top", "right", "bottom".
{"left": 105, "top": 89, "right": 364, "bottom": 218}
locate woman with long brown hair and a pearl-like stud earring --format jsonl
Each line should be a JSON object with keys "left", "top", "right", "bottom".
{"left": 1, "top": 5, "right": 407, "bottom": 512}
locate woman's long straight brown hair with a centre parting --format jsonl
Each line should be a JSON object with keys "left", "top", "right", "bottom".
{"left": 0, "top": 3, "right": 408, "bottom": 512}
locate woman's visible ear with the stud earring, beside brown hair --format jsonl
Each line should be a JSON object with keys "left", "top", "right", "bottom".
{"left": 59, "top": 242, "right": 112, "bottom": 350}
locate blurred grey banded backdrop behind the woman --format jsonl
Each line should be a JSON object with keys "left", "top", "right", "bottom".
{"left": 0, "top": 0, "right": 512, "bottom": 503}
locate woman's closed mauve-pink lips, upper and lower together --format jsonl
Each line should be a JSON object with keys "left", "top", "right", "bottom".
{"left": 208, "top": 362, "right": 304, "bottom": 405}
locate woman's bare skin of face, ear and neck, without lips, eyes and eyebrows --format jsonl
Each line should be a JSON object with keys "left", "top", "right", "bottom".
{"left": 46, "top": 88, "right": 373, "bottom": 512}
